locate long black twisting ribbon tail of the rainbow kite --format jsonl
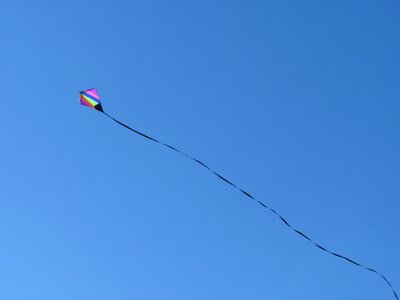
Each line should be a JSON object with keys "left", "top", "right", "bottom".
{"left": 103, "top": 111, "right": 399, "bottom": 300}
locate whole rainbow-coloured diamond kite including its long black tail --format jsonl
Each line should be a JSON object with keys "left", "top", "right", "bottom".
{"left": 79, "top": 88, "right": 399, "bottom": 300}
